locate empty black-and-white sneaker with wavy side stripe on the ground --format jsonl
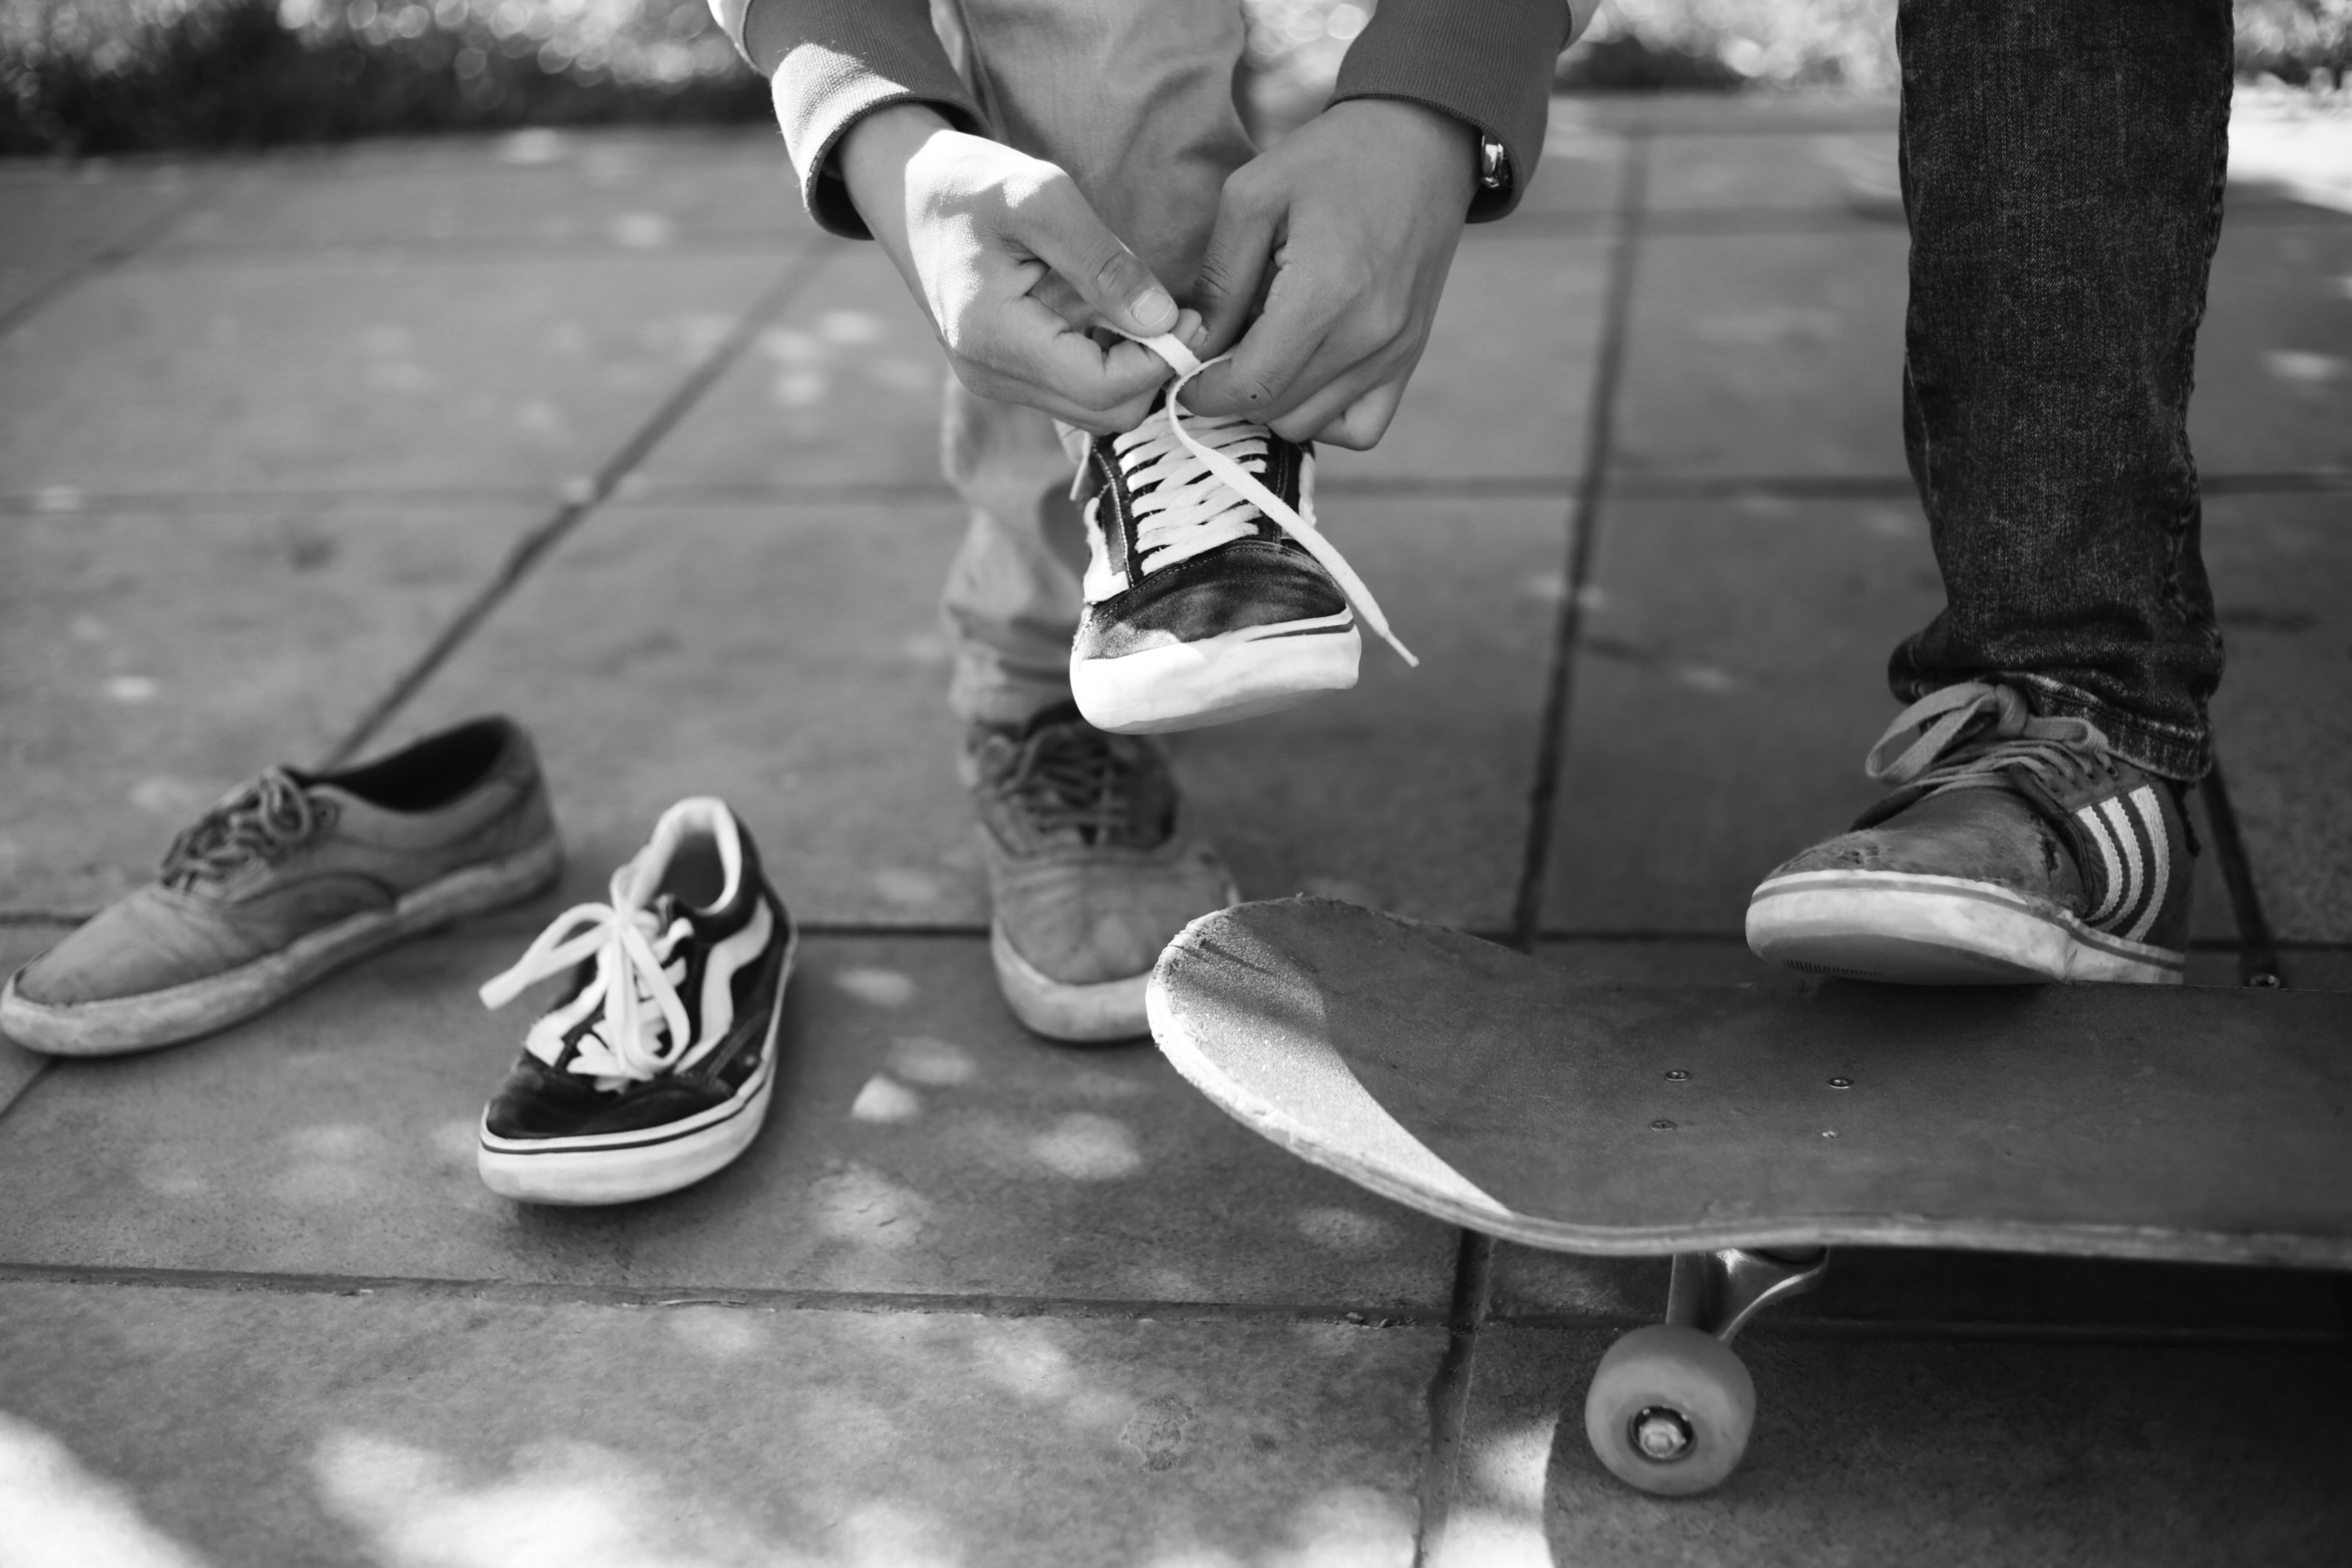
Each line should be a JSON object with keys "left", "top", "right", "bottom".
{"left": 480, "top": 797, "right": 797, "bottom": 1203}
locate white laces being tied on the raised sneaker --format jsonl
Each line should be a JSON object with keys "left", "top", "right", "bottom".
{"left": 1122, "top": 332, "right": 1421, "bottom": 668}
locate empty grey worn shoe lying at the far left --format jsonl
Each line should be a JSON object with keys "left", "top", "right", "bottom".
{"left": 0, "top": 720, "right": 562, "bottom": 1055}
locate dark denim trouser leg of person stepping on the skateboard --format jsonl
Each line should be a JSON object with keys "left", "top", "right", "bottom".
{"left": 1889, "top": 0, "right": 2230, "bottom": 779}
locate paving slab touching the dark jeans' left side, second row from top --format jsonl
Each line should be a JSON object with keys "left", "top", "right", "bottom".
{"left": 1616, "top": 226, "right": 1910, "bottom": 480}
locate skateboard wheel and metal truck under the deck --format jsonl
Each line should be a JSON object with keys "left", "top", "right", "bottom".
{"left": 1585, "top": 1246, "right": 1830, "bottom": 1497}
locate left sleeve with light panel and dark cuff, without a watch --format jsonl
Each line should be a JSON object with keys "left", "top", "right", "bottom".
{"left": 710, "top": 0, "right": 981, "bottom": 240}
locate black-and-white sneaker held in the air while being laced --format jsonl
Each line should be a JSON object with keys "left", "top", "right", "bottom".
{"left": 1070, "top": 339, "right": 1416, "bottom": 736}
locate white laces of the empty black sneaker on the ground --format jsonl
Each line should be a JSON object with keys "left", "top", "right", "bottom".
{"left": 482, "top": 865, "right": 694, "bottom": 1088}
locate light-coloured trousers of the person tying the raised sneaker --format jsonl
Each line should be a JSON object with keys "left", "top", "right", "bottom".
{"left": 931, "top": 0, "right": 1254, "bottom": 724}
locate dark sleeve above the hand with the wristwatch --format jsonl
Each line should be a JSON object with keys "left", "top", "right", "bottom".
{"left": 1336, "top": 0, "right": 1595, "bottom": 223}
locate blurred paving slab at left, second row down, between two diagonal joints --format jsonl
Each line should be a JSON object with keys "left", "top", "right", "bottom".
{"left": 0, "top": 252, "right": 788, "bottom": 499}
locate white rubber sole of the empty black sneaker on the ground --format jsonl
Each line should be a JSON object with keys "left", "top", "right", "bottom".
{"left": 475, "top": 935, "right": 800, "bottom": 1208}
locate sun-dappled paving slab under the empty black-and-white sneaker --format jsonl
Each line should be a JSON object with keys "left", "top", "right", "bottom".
{"left": 0, "top": 931, "right": 1454, "bottom": 1316}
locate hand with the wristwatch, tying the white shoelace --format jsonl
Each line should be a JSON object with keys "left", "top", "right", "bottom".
{"left": 1183, "top": 99, "right": 1477, "bottom": 449}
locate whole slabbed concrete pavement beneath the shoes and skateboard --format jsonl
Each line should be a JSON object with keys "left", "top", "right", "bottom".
{"left": 0, "top": 99, "right": 2352, "bottom": 1568}
